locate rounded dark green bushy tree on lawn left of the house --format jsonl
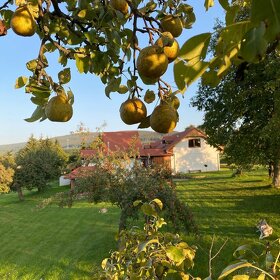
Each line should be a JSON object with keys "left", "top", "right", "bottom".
{"left": 14, "top": 137, "right": 67, "bottom": 194}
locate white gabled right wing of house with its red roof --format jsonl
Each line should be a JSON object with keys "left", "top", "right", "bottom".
{"left": 141, "top": 126, "right": 220, "bottom": 173}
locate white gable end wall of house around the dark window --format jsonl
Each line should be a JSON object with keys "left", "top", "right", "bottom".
{"left": 171, "top": 137, "right": 220, "bottom": 173}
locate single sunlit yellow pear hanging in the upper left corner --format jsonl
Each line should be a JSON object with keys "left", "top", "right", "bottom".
{"left": 11, "top": 5, "right": 36, "bottom": 37}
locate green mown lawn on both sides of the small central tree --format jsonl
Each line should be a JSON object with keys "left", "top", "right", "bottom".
{"left": 0, "top": 167, "right": 280, "bottom": 280}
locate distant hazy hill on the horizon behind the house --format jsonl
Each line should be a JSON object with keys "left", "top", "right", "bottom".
{"left": 0, "top": 131, "right": 162, "bottom": 154}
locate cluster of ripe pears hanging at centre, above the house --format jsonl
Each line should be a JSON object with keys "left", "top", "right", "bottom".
{"left": 120, "top": 15, "right": 183, "bottom": 133}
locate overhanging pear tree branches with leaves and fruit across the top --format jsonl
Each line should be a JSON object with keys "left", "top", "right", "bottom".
{"left": 0, "top": 0, "right": 280, "bottom": 133}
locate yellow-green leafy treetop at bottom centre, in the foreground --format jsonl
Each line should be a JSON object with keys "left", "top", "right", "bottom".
{"left": 100, "top": 199, "right": 196, "bottom": 280}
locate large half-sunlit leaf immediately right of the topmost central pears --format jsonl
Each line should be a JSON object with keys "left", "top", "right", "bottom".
{"left": 179, "top": 32, "right": 211, "bottom": 60}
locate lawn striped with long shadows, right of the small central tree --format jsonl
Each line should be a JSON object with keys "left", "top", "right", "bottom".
{"left": 177, "top": 169, "right": 280, "bottom": 279}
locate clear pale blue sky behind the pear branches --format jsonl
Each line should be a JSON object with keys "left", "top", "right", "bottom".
{"left": 0, "top": 0, "right": 223, "bottom": 145}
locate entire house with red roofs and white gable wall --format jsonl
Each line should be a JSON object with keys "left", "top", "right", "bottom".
{"left": 66, "top": 126, "right": 220, "bottom": 184}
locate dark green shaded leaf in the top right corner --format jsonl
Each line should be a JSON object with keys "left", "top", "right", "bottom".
{"left": 251, "top": 0, "right": 280, "bottom": 41}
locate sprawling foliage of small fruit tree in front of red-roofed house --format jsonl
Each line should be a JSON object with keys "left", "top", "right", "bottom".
{"left": 60, "top": 144, "right": 197, "bottom": 231}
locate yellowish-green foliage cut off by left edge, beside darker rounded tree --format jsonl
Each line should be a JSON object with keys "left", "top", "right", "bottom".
{"left": 0, "top": 153, "right": 15, "bottom": 193}
